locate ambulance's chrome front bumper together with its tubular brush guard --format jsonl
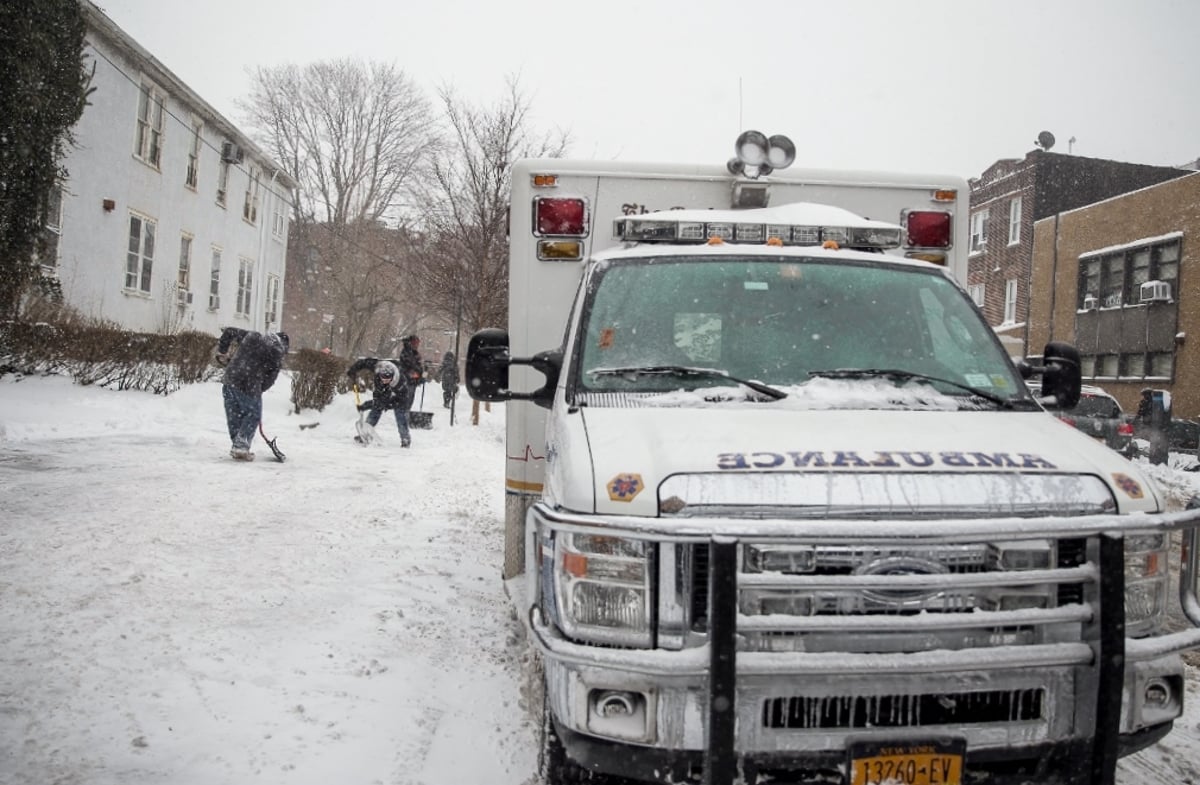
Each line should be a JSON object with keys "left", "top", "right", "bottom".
{"left": 529, "top": 508, "right": 1200, "bottom": 783}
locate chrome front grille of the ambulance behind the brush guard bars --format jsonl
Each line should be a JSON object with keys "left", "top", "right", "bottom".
{"left": 673, "top": 538, "right": 1096, "bottom": 654}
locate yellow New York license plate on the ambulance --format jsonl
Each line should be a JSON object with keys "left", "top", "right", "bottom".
{"left": 850, "top": 738, "right": 967, "bottom": 785}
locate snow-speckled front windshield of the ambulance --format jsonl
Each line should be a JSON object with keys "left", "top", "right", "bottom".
{"left": 578, "top": 257, "right": 1028, "bottom": 401}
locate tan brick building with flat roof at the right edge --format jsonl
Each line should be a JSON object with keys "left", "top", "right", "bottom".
{"left": 1028, "top": 172, "right": 1200, "bottom": 418}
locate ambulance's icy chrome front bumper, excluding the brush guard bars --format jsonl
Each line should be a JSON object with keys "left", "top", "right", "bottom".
{"left": 540, "top": 611, "right": 1182, "bottom": 783}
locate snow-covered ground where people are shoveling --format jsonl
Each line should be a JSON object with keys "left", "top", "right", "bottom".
{"left": 0, "top": 376, "right": 1200, "bottom": 785}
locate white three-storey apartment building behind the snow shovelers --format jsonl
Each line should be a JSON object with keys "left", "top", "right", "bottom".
{"left": 42, "top": 0, "right": 296, "bottom": 335}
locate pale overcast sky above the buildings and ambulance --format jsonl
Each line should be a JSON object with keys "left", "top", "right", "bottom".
{"left": 98, "top": 0, "right": 1200, "bottom": 176}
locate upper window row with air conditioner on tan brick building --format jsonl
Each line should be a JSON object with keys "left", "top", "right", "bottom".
{"left": 1076, "top": 238, "right": 1180, "bottom": 310}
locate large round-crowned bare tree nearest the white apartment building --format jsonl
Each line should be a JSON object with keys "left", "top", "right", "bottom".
{"left": 241, "top": 60, "right": 439, "bottom": 354}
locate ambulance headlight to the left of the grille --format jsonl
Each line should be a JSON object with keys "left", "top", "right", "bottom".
{"left": 553, "top": 532, "right": 650, "bottom": 648}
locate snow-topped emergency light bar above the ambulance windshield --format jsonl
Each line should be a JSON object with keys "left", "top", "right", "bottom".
{"left": 613, "top": 202, "right": 901, "bottom": 250}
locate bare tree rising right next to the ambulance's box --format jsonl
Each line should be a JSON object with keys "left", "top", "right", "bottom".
{"left": 415, "top": 77, "right": 570, "bottom": 332}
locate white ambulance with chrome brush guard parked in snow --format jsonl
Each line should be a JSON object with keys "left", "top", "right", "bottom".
{"left": 467, "top": 132, "right": 1200, "bottom": 785}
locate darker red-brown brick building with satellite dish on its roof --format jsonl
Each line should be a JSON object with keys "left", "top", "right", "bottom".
{"left": 967, "top": 150, "right": 1188, "bottom": 356}
